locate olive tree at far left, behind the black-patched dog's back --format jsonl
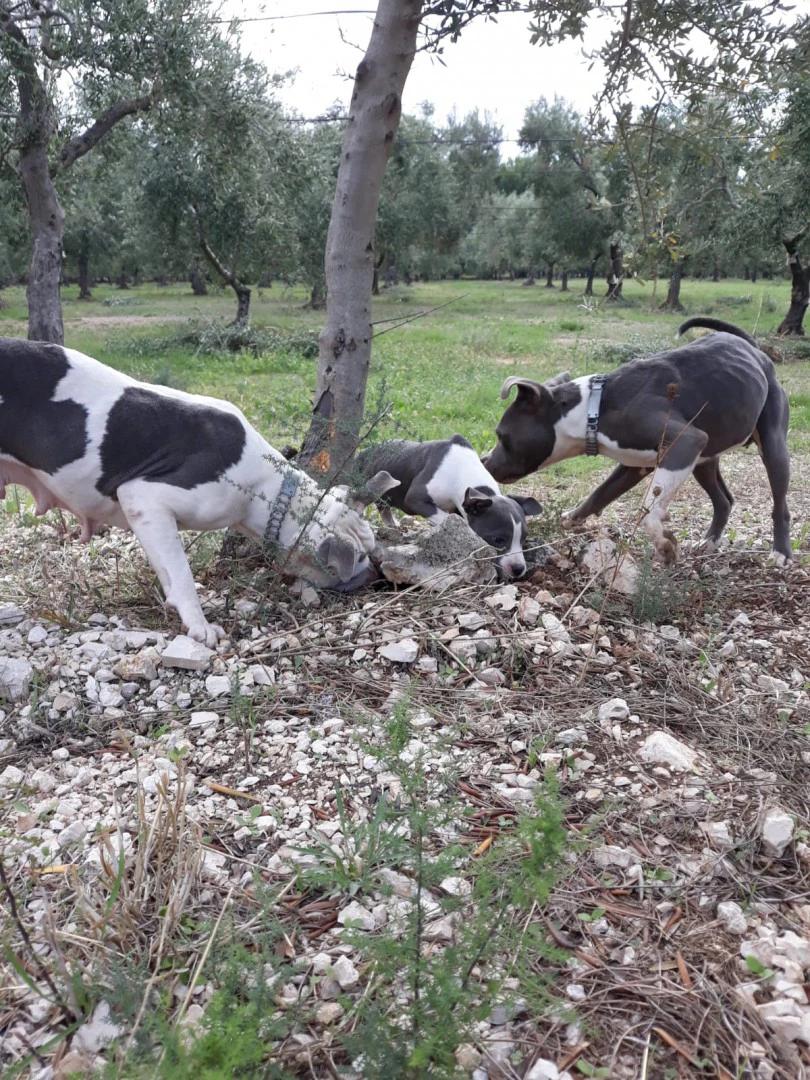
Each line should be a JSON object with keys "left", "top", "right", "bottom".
{"left": 0, "top": 0, "right": 246, "bottom": 342}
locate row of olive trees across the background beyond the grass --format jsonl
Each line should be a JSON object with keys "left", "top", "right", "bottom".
{"left": 0, "top": 0, "right": 810, "bottom": 339}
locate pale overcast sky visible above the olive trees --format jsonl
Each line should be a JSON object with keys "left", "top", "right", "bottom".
{"left": 228, "top": 0, "right": 603, "bottom": 147}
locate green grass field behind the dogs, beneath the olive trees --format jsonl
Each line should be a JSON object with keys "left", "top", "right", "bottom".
{"left": 0, "top": 280, "right": 810, "bottom": 457}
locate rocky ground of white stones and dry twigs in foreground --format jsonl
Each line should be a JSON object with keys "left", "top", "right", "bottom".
{"left": 0, "top": 455, "right": 810, "bottom": 1080}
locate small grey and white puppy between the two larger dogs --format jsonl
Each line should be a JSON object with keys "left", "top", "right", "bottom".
{"left": 355, "top": 435, "right": 540, "bottom": 578}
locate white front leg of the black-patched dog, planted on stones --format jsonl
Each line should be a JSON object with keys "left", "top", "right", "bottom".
{"left": 118, "top": 480, "right": 225, "bottom": 648}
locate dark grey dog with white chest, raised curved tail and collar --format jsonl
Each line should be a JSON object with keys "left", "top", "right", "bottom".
{"left": 484, "top": 318, "right": 793, "bottom": 565}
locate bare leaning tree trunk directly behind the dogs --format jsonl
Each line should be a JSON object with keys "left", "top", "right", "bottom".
{"left": 298, "top": 0, "right": 422, "bottom": 478}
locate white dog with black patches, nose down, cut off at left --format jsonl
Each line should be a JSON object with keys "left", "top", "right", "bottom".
{"left": 0, "top": 338, "right": 395, "bottom": 646}
